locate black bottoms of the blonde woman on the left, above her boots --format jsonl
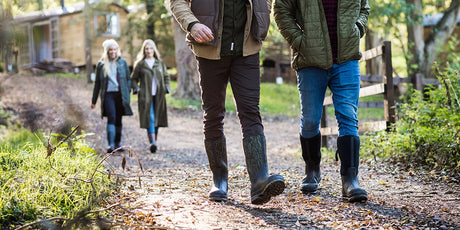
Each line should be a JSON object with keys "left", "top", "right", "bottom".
{"left": 104, "top": 92, "right": 123, "bottom": 126}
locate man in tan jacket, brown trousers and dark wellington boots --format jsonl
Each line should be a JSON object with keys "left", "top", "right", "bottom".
{"left": 170, "top": 0, "right": 285, "bottom": 204}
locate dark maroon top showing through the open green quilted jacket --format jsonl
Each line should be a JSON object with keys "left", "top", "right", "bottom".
{"left": 323, "top": 0, "right": 338, "bottom": 64}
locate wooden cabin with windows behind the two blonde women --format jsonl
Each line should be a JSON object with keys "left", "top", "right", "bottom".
{"left": 14, "top": 2, "right": 142, "bottom": 69}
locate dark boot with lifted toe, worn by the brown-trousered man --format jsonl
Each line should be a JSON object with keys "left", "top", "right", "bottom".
{"left": 243, "top": 135, "right": 286, "bottom": 204}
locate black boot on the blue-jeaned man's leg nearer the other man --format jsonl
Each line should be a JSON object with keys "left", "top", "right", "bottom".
{"left": 300, "top": 133, "right": 321, "bottom": 194}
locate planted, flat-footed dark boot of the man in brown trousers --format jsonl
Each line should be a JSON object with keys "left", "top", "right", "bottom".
{"left": 204, "top": 136, "right": 228, "bottom": 201}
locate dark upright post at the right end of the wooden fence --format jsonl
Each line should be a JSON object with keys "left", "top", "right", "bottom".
{"left": 382, "top": 41, "right": 396, "bottom": 128}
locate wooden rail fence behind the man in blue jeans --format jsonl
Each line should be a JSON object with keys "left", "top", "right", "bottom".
{"left": 320, "top": 41, "right": 401, "bottom": 147}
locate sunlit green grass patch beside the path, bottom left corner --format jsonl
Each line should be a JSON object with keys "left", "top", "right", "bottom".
{"left": 0, "top": 129, "right": 111, "bottom": 229}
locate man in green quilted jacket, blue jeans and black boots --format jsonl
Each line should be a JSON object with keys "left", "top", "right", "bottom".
{"left": 274, "top": 0, "right": 370, "bottom": 202}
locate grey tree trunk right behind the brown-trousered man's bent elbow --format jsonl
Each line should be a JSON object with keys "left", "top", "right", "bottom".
{"left": 171, "top": 18, "right": 200, "bottom": 100}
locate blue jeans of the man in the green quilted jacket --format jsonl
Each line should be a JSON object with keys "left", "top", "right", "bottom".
{"left": 297, "top": 60, "right": 361, "bottom": 138}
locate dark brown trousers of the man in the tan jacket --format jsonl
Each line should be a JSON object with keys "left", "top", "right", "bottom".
{"left": 197, "top": 54, "right": 264, "bottom": 139}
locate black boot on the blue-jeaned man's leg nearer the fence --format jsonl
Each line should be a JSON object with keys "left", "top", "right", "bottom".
{"left": 337, "top": 136, "right": 367, "bottom": 202}
